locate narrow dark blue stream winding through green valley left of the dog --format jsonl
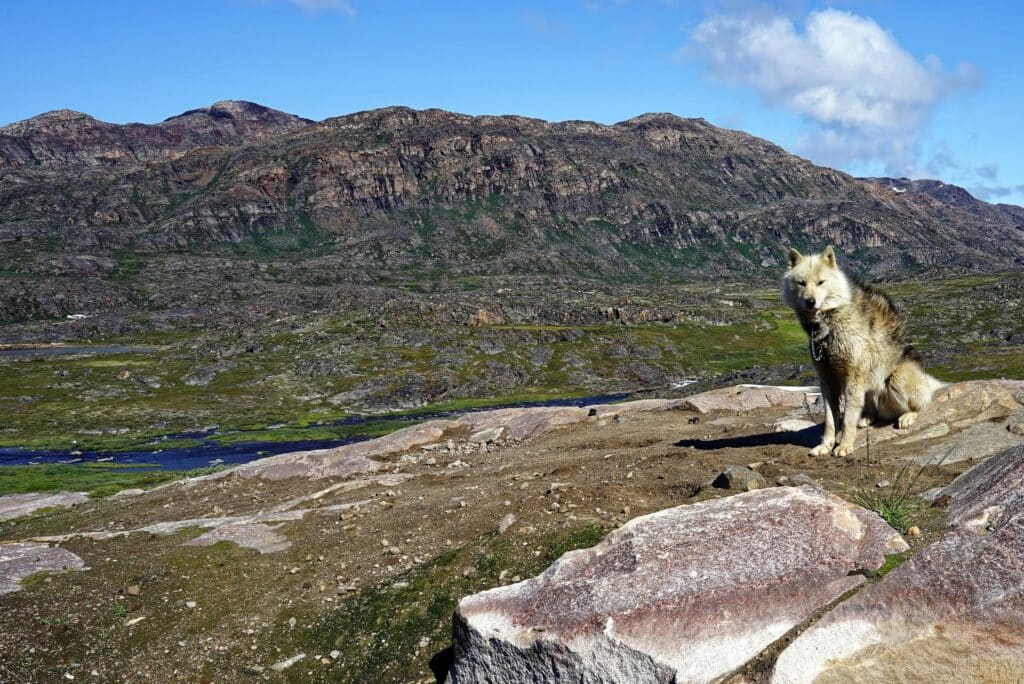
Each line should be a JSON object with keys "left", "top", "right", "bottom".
{"left": 0, "top": 389, "right": 633, "bottom": 470}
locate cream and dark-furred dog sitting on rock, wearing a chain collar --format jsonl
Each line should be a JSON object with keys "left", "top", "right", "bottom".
{"left": 782, "top": 247, "right": 942, "bottom": 456}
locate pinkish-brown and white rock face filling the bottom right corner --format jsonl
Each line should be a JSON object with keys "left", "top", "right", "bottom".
{"left": 772, "top": 440, "right": 1024, "bottom": 684}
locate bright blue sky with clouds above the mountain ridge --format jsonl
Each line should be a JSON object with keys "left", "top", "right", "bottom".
{"left": 6, "top": 0, "right": 1024, "bottom": 204}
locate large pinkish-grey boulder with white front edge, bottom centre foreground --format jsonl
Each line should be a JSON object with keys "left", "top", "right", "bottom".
{"left": 450, "top": 486, "right": 906, "bottom": 682}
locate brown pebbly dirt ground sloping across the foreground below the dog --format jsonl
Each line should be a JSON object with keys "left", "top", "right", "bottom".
{"left": 0, "top": 397, "right": 970, "bottom": 682}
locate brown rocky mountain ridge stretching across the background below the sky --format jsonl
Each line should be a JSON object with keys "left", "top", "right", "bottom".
{"left": 0, "top": 102, "right": 1024, "bottom": 279}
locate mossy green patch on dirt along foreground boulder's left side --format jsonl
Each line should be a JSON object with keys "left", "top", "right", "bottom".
{"left": 285, "top": 524, "right": 605, "bottom": 682}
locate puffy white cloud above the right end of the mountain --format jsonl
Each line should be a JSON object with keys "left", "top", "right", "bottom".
{"left": 686, "top": 9, "right": 980, "bottom": 172}
